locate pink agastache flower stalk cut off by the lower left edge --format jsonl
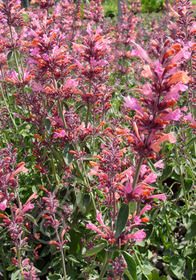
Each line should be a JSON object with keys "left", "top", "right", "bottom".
{"left": 0, "top": 146, "right": 39, "bottom": 280}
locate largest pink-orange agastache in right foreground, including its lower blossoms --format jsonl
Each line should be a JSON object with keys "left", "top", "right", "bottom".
{"left": 87, "top": 26, "right": 191, "bottom": 279}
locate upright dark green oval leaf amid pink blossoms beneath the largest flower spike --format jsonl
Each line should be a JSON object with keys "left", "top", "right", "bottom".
{"left": 115, "top": 203, "right": 129, "bottom": 239}
